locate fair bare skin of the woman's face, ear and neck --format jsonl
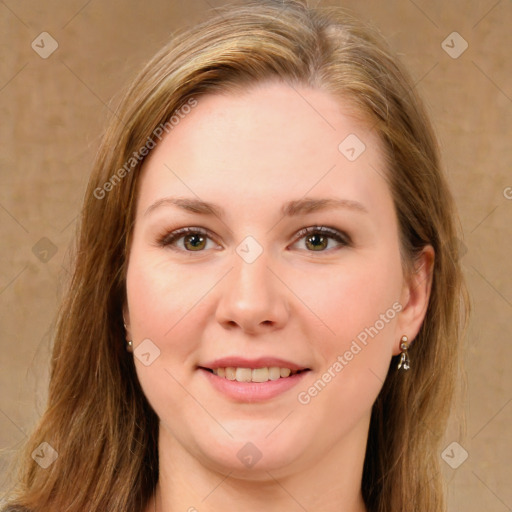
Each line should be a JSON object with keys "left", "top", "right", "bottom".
{"left": 124, "top": 82, "right": 433, "bottom": 512}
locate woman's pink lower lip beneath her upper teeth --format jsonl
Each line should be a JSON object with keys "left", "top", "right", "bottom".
{"left": 199, "top": 368, "right": 309, "bottom": 402}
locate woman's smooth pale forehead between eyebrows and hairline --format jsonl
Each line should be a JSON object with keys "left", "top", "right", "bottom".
{"left": 138, "top": 82, "right": 390, "bottom": 221}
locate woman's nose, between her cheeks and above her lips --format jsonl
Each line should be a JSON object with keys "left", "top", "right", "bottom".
{"left": 216, "top": 252, "right": 289, "bottom": 334}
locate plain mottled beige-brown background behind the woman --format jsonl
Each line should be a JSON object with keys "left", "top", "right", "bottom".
{"left": 0, "top": 0, "right": 512, "bottom": 512}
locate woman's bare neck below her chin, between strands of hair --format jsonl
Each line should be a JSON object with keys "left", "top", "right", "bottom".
{"left": 147, "top": 416, "right": 368, "bottom": 512}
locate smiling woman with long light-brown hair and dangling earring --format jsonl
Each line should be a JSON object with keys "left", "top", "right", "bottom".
{"left": 4, "top": 1, "right": 466, "bottom": 512}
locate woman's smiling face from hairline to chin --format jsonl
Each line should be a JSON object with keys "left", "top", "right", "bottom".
{"left": 125, "top": 83, "right": 428, "bottom": 477}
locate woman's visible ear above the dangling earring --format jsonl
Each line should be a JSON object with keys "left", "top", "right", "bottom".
{"left": 393, "top": 245, "right": 435, "bottom": 355}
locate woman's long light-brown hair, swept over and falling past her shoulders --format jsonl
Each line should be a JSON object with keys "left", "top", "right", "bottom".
{"left": 4, "top": 0, "right": 468, "bottom": 512}
